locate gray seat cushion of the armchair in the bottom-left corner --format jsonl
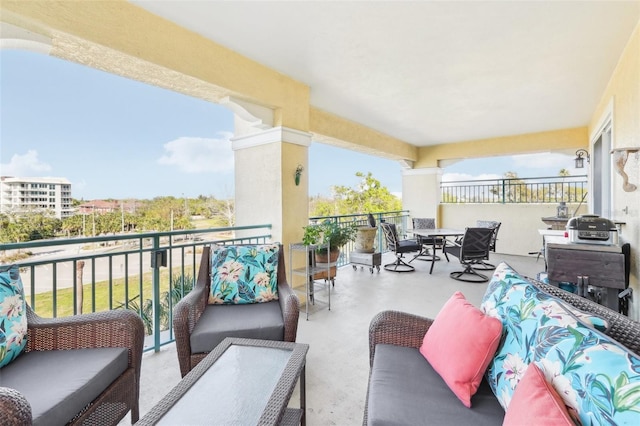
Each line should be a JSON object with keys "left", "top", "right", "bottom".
{"left": 0, "top": 348, "right": 129, "bottom": 425}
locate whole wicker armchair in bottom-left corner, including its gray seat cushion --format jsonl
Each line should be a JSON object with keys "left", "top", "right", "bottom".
{"left": 0, "top": 305, "right": 144, "bottom": 425}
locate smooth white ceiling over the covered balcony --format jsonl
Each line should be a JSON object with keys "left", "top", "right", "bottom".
{"left": 132, "top": 0, "right": 640, "bottom": 146}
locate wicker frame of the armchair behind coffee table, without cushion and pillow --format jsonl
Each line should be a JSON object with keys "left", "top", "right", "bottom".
{"left": 173, "top": 246, "right": 300, "bottom": 377}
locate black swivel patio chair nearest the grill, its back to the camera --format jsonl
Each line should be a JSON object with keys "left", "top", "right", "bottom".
{"left": 442, "top": 228, "right": 493, "bottom": 283}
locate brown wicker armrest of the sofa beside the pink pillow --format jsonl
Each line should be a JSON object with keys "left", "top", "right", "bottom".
{"left": 369, "top": 311, "right": 433, "bottom": 365}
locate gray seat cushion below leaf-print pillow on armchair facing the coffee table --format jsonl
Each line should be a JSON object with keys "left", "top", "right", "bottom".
{"left": 190, "top": 300, "right": 284, "bottom": 353}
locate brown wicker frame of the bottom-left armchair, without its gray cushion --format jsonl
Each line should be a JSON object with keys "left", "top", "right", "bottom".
{"left": 0, "top": 305, "right": 144, "bottom": 425}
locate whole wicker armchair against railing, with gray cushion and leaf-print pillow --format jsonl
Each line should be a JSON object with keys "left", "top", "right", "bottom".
{"left": 173, "top": 244, "right": 300, "bottom": 377}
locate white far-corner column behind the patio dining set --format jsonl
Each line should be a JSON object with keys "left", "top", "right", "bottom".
{"left": 402, "top": 167, "right": 443, "bottom": 227}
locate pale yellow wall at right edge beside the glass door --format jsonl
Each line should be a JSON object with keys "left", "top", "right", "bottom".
{"left": 589, "top": 22, "right": 640, "bottom": 321}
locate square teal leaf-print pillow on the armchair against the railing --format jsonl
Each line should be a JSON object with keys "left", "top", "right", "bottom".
{"left": 209, "top": 244, "right": 280, "bottom": 304}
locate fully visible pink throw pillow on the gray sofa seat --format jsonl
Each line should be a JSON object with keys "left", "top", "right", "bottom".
{"left": 420, "top": 291, "right": 502, "bottom": 407}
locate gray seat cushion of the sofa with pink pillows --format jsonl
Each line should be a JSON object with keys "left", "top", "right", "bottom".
{"left": 367, "top": 345, "right": 504, "bottom": 426}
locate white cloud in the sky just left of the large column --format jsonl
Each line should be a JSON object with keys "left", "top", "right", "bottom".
{"left": 158, "top": 132, "right": 233, "bottom": 173}
